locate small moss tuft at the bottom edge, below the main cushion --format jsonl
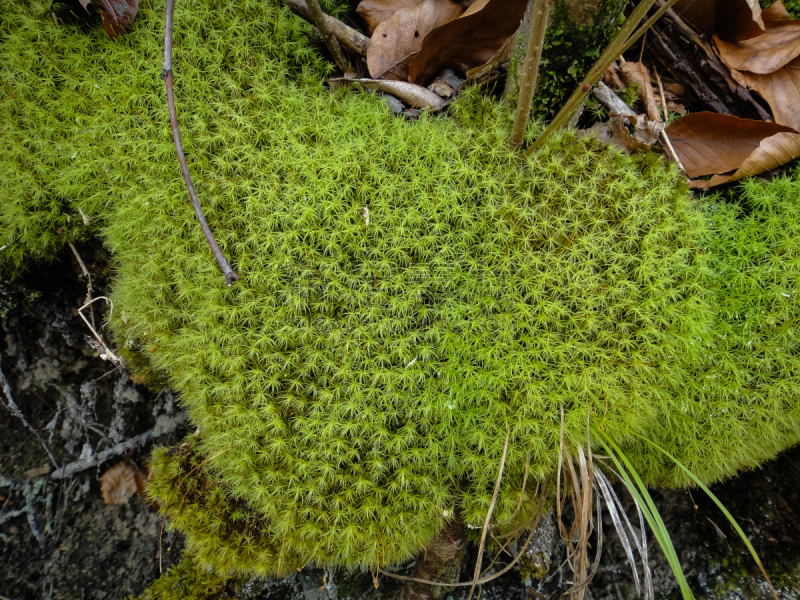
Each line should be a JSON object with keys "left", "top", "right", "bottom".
{"left": 129, "top": 552, "right": 229, "bottom": 600}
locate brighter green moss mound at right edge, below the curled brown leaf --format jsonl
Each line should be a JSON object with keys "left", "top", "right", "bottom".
{"left": 626, "top": 176, "right": 800, "bottom": 485}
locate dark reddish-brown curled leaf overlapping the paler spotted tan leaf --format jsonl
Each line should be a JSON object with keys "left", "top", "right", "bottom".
{"left": 408, "top": 0, "right": 528, "bottom": 84}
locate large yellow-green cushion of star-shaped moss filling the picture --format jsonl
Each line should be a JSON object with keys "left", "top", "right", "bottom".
{"left": 0, "top": 0, "right": 800, "bottom": 584}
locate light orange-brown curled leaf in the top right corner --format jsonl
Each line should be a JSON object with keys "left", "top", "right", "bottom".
{"left": 714, "top": 0, "right": 800, "bottom": 130}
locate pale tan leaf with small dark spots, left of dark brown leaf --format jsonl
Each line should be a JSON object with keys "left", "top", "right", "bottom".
{"left": 367, "top": 0, "right": 463, "bottom": 81}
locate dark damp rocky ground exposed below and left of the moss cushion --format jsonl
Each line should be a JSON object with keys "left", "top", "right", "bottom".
{"left": 0, "top": 246, "right": 800, "bottom": 600}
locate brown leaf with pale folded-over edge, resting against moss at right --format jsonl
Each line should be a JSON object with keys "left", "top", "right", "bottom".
{"left": 666, "top": 112, "right": 800, "bottom": 188}
